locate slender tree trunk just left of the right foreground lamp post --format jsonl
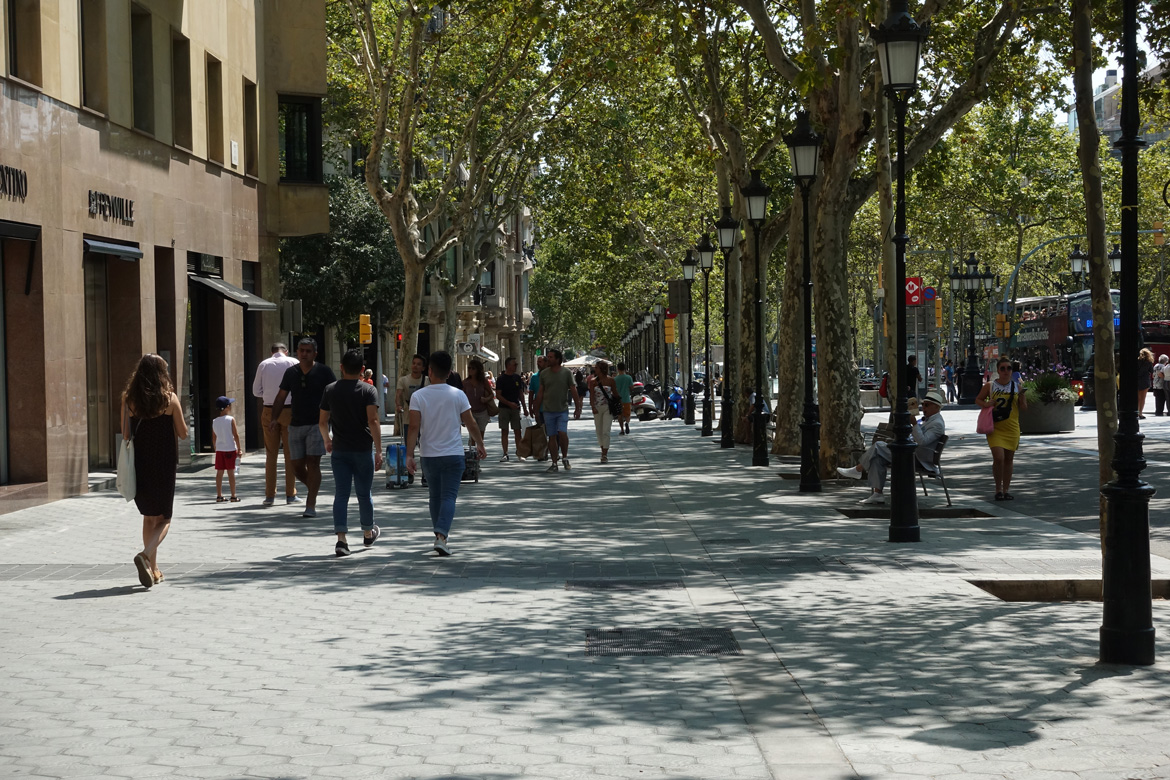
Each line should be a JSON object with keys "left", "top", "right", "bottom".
{"left": 1073, "top": 0, "right": 1113, "bottom": 530}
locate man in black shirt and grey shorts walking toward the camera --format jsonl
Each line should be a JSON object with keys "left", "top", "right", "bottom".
{"left": 273, "top": 338, "right": 337, "bottom": 517}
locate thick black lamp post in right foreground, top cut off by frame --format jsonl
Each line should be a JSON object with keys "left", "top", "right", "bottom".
{"left": 1099, "top": 0, "right": 1155, "bottom": 665}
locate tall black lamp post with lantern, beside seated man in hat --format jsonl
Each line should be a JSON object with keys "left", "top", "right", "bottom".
{"left": 869, "top": 0, "right": 930, "bottom": 541}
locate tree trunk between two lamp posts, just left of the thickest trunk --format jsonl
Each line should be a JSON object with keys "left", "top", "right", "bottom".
{"left": 772, "top": 191, "right": 815, "bottom": 455}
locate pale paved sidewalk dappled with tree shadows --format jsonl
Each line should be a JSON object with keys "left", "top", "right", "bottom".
{"left": 0, "top": 416, "right": 1170, "bottom": 780}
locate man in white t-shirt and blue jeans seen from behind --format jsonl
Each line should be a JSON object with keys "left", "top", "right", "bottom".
{"left": 406, "top": 352, "right": 488, "bottom": 555}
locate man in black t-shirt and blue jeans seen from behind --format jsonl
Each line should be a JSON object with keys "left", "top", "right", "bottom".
{"left": 318, "top": 350, "right": 381, "bottom": 558}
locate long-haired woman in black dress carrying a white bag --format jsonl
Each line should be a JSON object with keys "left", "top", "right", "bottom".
{"left": 122, "top": 354, "right": 187, "bottom": 588}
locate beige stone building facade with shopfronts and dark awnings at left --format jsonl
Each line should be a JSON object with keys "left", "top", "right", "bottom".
{"left": 0, "top": 0, "right": 329, "bottom": 502}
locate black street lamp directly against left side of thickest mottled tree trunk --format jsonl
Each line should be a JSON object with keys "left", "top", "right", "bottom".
{"left": 784, "top": 111, "right": 820, "bottom": 492}
